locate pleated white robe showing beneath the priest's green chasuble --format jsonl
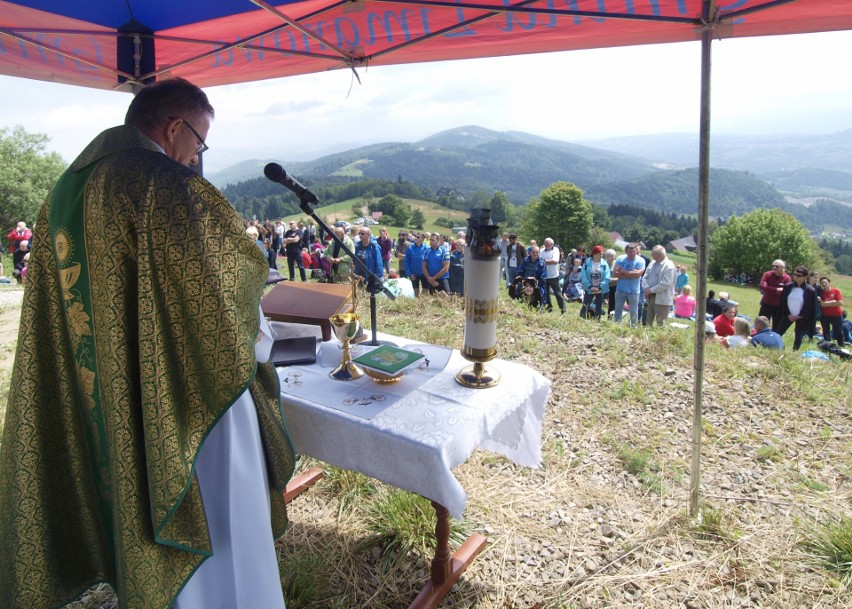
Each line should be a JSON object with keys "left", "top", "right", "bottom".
{"left": 172, "top": 315, "right": 284, "bottom": 609}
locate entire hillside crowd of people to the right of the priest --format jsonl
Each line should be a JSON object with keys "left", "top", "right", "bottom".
{"left": 233, "top": 221, "right": 852, "bottom": 350}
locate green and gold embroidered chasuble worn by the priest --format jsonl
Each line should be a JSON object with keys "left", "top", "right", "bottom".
{"left": 0, "top": 127, "right": 294, "bottom": 609}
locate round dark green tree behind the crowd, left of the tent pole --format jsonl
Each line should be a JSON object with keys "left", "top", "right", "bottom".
{"left": 521, "top": 182, "right": 592, "bottom": 249}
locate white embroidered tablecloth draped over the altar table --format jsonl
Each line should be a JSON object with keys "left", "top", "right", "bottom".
{"left": 279, "top": 334, "right": 550, "bottom": 518}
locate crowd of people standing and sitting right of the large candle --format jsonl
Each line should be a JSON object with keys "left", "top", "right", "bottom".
{"left": 501, "top": 233, "right": 852, "bottom": 350}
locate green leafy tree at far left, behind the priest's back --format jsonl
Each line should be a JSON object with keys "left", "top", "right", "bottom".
{"left": 0, "top": 125, "right": 65, "bottom": 235}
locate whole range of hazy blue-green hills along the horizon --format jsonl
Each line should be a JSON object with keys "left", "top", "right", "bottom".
{"left": 209, "top": 126, "right": 852, "bottom": 232}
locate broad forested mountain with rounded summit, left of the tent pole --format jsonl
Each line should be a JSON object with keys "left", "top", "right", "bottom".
{"left": 209, "top": 127, "right": 659, "bottom": 205}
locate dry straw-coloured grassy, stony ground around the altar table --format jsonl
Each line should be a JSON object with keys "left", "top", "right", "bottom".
{"left": 1, "top": 288, "right": 852, "bottom": 609}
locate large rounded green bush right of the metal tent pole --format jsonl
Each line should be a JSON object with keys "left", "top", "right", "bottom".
{"left": 708, "top": 208, "right": 826, "bottom": 278}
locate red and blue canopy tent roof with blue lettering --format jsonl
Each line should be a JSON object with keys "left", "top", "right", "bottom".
{"left": 0, "top": 0, "right": 852, "bottom": 89}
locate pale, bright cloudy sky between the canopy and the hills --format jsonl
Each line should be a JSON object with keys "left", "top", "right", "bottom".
{"left": 0, "top": 32, "right": 852, "bottom": 171}
